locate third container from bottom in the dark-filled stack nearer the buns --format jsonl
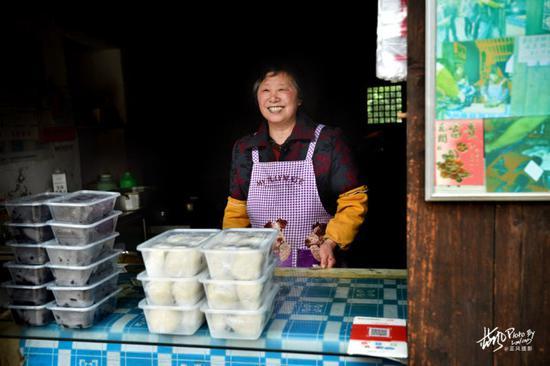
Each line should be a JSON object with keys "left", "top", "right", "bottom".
{"left": 46, "top": 250, "right": 122, "bottom": 287}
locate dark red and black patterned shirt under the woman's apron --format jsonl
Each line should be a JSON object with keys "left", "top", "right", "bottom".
{"left": 229, "top": 113, "right": 361, "bottom": 214}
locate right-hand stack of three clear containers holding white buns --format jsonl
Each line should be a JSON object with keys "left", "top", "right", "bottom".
{"left": 200, "top": 229, "right": 279, "bottom": 340}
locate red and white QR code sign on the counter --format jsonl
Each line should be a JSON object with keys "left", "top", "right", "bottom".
{"left": 348, "top": 317, "right": 407, "bottom": 358}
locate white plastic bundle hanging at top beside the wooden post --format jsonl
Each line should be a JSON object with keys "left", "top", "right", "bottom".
{"left": 376, "top": 0, "right": 407, "bottom": 82}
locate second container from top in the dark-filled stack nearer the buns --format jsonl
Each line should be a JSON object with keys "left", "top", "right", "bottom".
{"left": 48, "top": 211, "right": 122, "bottom": 245}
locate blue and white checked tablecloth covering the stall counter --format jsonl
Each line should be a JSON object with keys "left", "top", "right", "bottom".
{"left": 0, "top": 270, "right": 407, "bottom": 366}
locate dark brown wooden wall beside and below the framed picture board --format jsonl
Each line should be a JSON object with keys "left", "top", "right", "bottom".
{"left": 407, "top": 0, "right": 550, "bottom": 365}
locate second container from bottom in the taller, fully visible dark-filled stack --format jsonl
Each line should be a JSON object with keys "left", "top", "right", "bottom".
{"left": 48, "top": 270, "right": 122, "bottom": 308}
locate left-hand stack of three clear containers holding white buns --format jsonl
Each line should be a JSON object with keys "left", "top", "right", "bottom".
{"left": 137, "top": 229, "right": 219, "bottom": 335}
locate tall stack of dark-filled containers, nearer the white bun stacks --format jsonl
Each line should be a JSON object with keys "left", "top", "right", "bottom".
{"left": 44, "top": 191, "right": 121, "bottom": 328}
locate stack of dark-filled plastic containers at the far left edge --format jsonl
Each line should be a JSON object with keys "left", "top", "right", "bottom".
{"left": 2, "top": 193, "right": 61, "bottom": 325}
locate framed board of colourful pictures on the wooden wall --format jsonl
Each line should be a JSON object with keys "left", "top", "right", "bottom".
{"left": 426, "top": 0, "right": 550, "bottom": 201}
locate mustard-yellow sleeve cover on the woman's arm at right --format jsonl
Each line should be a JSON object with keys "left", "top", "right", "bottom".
{"left": 325, "top": 186, "right": 368, "bottom": 249}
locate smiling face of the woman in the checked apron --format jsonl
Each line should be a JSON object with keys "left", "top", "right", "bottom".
{"left": 257, "top": 72, "right": 301, "bottom": 123}
